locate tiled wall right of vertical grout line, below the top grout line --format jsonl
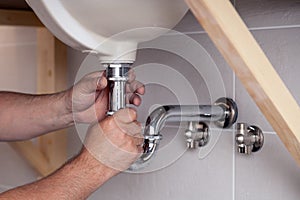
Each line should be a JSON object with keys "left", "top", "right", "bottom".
{"left": 236, "top": 24, "right": 300, "bottom": 200}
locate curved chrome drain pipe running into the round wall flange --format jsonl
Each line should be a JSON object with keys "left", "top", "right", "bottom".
{"left": 128, "top": 98, "right": 238, "bottom": 170}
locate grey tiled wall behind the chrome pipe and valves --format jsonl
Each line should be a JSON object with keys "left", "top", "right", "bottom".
{"left": 69, "top": 0, "right": 300, "bottom": 200}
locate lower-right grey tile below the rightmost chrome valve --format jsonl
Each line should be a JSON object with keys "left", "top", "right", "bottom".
{"left": 235, "top": 134, "right": 300, "bottom": 200}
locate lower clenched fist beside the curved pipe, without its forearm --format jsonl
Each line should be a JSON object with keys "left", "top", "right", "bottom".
{"left": 83, "top": 108, "right": 144, "bottom": 174}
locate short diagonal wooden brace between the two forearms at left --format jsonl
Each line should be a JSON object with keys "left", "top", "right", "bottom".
{"left": 9, "top": 141, "right": 52, "bottom": 176}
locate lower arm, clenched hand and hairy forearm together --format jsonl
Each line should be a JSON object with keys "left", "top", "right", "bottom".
{"left": 0, "top": 108, "right": 143, "bottom": 199}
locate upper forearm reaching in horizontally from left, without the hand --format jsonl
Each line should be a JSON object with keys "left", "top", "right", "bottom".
{"left": 0, "top": 92, "right": 73, "bottom": 141}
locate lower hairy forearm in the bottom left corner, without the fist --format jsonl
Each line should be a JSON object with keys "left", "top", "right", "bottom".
{"left": 0, "top": 150, "right": 116, "bottom": 200}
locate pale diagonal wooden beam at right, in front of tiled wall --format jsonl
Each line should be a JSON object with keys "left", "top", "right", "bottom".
{"left": 185, "top": 0, "right": 300, "bottom": 165}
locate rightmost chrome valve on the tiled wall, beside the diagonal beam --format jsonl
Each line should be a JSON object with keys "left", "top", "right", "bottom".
{"left": 235, "top": 123, "right": 264, "bottom": 155}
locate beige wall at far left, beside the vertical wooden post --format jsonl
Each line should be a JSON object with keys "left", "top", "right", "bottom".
{"left": 0, "top": 26, "right": 38, "bottom": 192}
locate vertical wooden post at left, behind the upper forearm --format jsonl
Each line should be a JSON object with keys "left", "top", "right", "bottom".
{"left": 37, "top": 28, "right": 67, "bottom": 171}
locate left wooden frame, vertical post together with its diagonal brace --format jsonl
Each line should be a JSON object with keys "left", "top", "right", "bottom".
{"left": 9, "top": 28, "right": 67, "bottom": 176}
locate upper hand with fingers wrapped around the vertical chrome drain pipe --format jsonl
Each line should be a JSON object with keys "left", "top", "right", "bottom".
{"left": 66, "top": 70, "right": 145, "bottom": 123}
